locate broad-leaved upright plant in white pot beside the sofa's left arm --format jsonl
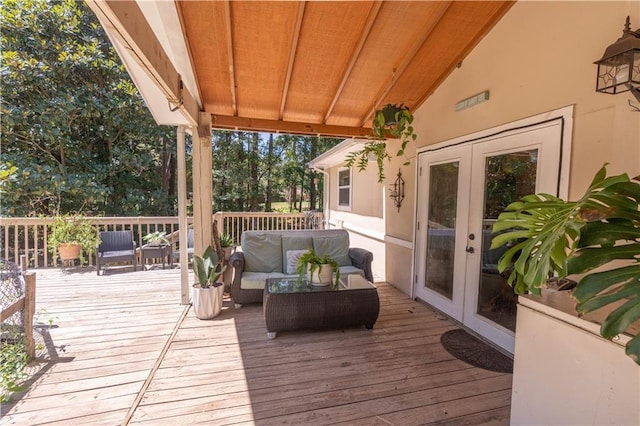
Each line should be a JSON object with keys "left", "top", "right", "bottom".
{"left": 192, "top": 246, "right": 226, "bottom": 319}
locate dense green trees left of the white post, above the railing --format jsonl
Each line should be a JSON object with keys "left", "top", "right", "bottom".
{"left": 0, "top": 0, "right": 175, "bottom": 216}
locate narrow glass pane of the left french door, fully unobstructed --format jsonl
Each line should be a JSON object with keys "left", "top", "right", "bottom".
{"left": 425, "top": 162, "right": 459, "bottom": 299}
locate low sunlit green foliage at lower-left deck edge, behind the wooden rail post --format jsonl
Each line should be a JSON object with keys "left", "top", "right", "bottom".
{"left": 0, "top": 333, "right": 29, "bottom": 402}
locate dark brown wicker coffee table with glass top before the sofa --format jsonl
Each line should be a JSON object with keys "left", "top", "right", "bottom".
{"left": 262, "top": 274, "right": 380, "bottom": 339}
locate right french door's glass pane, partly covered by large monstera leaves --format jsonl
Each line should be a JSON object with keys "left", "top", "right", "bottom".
{"left": 477, "top": 150, "right": 538, "bottom": 331}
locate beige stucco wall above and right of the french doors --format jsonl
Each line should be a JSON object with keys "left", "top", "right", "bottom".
{"left": 415, "top": 1, "right": 640, "bottom": 198}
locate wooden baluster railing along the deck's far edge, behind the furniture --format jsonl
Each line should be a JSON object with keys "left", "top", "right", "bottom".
{"left": 0, "top": 212, "right": 323, "bottom": 268}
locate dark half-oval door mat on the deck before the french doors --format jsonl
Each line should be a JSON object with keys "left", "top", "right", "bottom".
{"left": 440, "top": 329, "right": 513, "bottom": 373}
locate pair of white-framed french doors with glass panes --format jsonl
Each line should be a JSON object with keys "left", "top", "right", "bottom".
{"left": 414, "top": 120, "right": 562, "bottom": 352}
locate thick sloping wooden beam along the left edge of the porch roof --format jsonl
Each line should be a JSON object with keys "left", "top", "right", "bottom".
{"left": 87, "top": 0, "right": 200, "bottom": 125}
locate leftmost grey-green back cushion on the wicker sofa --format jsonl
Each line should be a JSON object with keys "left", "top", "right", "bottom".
{"left": 241, "top": 231, "right": 282, "bottom": 272}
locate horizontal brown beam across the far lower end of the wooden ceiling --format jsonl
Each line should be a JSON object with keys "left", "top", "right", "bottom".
{"left": 211, "top": 115, "right": 371, "bottom": 138}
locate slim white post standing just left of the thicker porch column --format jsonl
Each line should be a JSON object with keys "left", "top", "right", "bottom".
{"left": 176, "top": 126, "right": 189, "bottom": 305}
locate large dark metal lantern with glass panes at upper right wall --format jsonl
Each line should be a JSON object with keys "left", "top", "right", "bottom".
{"left": 594, "top": 16, "right": 640, "bottom": 102}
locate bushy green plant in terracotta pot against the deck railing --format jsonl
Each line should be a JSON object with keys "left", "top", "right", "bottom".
{"left": 48, "top": 214, "right": 100, "bottom": 263}
